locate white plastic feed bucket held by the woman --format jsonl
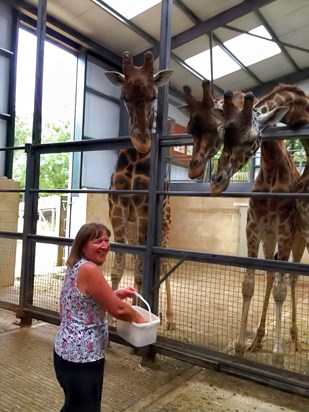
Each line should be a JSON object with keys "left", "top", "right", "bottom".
{"left": 116, "top": 293, "right": 160, "bottom": 348}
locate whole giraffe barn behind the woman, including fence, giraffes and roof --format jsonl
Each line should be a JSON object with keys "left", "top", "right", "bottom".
{"left": 0, "top": 0, "right": 309, "bottom": 396}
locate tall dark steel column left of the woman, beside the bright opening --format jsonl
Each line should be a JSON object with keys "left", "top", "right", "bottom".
{"left": 18, "top": 0, "right": 47, "bottom": 324}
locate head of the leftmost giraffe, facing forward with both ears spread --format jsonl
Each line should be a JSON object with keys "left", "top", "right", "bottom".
{"left": 105, "top": 51, "right": 174, "bottom": 153}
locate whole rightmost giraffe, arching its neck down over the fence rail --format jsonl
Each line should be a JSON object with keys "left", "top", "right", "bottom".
{"left": 207, "top": 84, "right": 309, "bottom": 365}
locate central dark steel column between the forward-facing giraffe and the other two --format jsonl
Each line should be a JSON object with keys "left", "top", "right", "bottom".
{"left": 143, "top": 0, "right": 173, "bottom": 312}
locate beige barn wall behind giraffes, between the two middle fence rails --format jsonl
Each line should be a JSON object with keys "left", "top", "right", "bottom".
{"left": 86, "top": 193, "right": 309, "bottom": 263}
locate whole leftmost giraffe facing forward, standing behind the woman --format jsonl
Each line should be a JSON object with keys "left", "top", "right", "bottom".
{"left": 105, "top": 51, "right": 175, "bottom": 329}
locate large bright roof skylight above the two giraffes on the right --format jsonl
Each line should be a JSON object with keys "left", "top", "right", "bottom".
{"left": 186, "top": 26, "right": 281, "bottom": 79}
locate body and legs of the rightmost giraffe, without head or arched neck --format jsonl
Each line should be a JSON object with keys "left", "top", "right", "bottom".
{"left": 235, "top": 141, "right": 305, "bottom": 365}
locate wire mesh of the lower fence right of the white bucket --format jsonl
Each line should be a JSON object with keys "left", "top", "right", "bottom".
{"left": 159, "top": 260, "right": 309, "bottom": 374}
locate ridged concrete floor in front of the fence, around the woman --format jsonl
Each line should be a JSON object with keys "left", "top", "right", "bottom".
{"left": 0, "top": 310, "right": 309, "bottom": 412}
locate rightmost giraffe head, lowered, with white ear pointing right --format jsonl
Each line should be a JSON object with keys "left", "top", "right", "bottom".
{"left": 211, "top": 92, "right": 289, "bottom": 196}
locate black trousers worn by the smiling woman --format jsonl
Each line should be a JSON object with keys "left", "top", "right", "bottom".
{"left": 54, "top": 352, "right": 105, "bottom": 412}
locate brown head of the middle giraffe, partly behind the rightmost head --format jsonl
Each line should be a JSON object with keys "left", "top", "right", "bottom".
{"left": 178, "top": 80, "right": 223, "bottom": 179}
